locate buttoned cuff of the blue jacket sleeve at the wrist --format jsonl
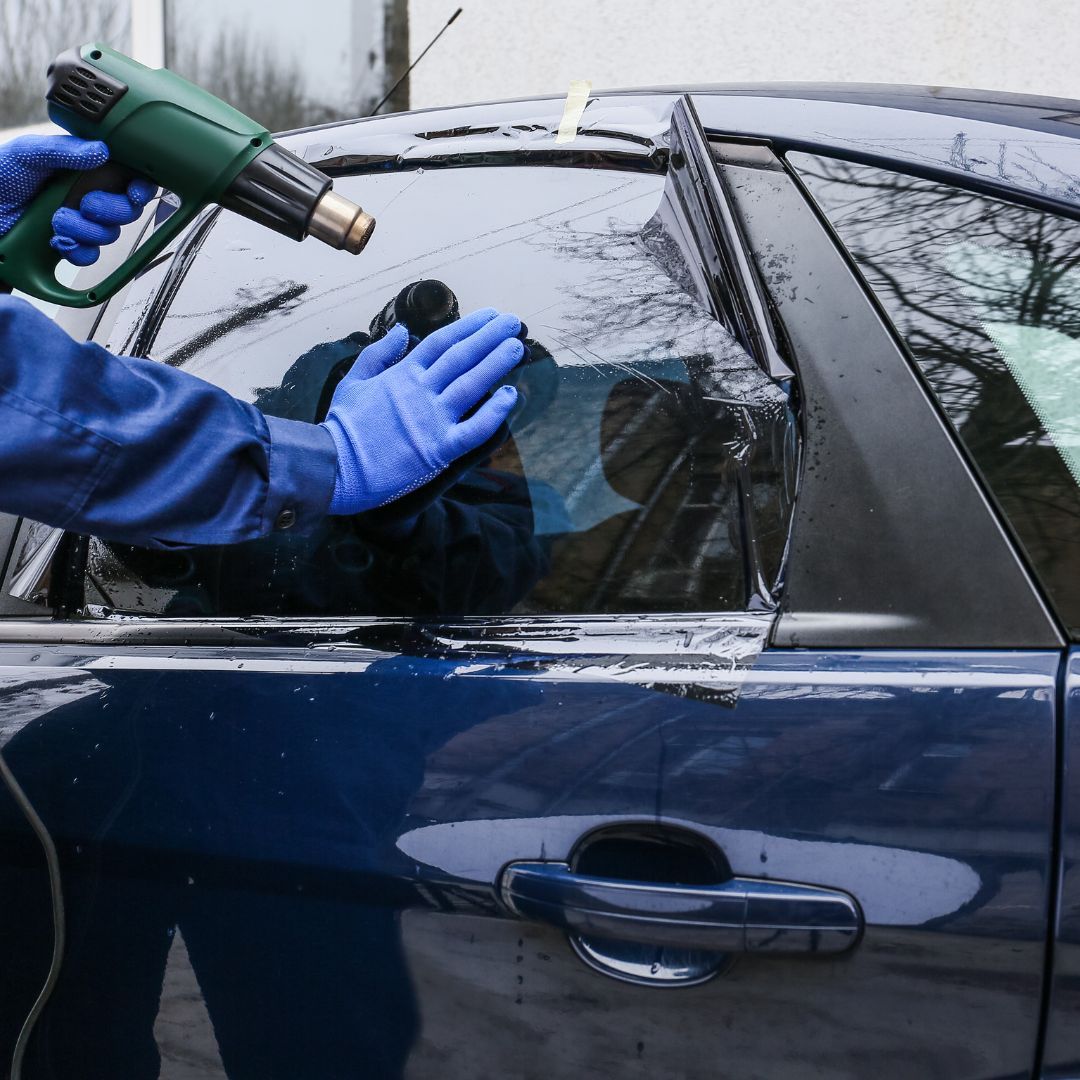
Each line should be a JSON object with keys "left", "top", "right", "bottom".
{"left": 262, "top": 416, "right": 337, "bottom": 532}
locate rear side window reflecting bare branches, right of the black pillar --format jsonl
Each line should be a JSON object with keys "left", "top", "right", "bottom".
{"left": 788, "top": 153, "right": 1080, "bottom": 637}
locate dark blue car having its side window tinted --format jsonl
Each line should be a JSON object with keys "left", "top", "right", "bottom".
{"left": 0, "top": 85, "right": 1080, "bottom": 1080}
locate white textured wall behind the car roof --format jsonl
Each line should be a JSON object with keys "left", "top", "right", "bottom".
{"left": 408, "top": 0, "right": 1080, "bottom": 108}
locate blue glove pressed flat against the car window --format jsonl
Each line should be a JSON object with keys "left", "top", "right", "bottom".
{"left": 323, "top": 308, "right": 525, "bottom": 514}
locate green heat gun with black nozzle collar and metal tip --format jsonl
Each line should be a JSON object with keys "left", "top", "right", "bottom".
{"left": 0, "top": 44, "right": 375, "bottom": 308}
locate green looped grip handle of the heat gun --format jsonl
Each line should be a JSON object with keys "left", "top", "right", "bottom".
{"left": 0, "top": 166, "right": 202, "bottom": 308}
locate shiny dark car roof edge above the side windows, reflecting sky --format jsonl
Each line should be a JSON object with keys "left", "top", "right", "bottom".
{"left": 287, "top": 83, "right": 1080, "bottom": 218}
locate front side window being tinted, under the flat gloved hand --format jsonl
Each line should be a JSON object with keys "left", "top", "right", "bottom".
{"left": 87, "top": 160, "right": 797, "bottom": 616}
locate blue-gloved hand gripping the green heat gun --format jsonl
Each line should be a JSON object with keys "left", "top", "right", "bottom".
{"left": 0, "top": 135, "right": 157, "bottom": 267}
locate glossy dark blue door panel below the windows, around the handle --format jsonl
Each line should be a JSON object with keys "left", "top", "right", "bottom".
{"left": 0, "top": 635, "right": 1057, "bottom": 1078}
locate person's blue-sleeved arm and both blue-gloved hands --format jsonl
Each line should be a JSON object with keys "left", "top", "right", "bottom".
{"left": 0, "top": 136, "right": 523, "bottom": 548}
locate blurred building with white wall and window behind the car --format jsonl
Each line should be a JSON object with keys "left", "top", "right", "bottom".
{"left": 0, "top": 0, "right": 1080, "bottom": 138}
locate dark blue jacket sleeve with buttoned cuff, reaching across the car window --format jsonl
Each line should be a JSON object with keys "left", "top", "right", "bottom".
{"left": 0, "top": 296, "right": 337, "bottom": 548}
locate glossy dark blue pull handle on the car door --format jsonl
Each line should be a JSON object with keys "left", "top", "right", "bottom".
{"left": 500, "top": 862, "right": 863, "bottom": 954}
